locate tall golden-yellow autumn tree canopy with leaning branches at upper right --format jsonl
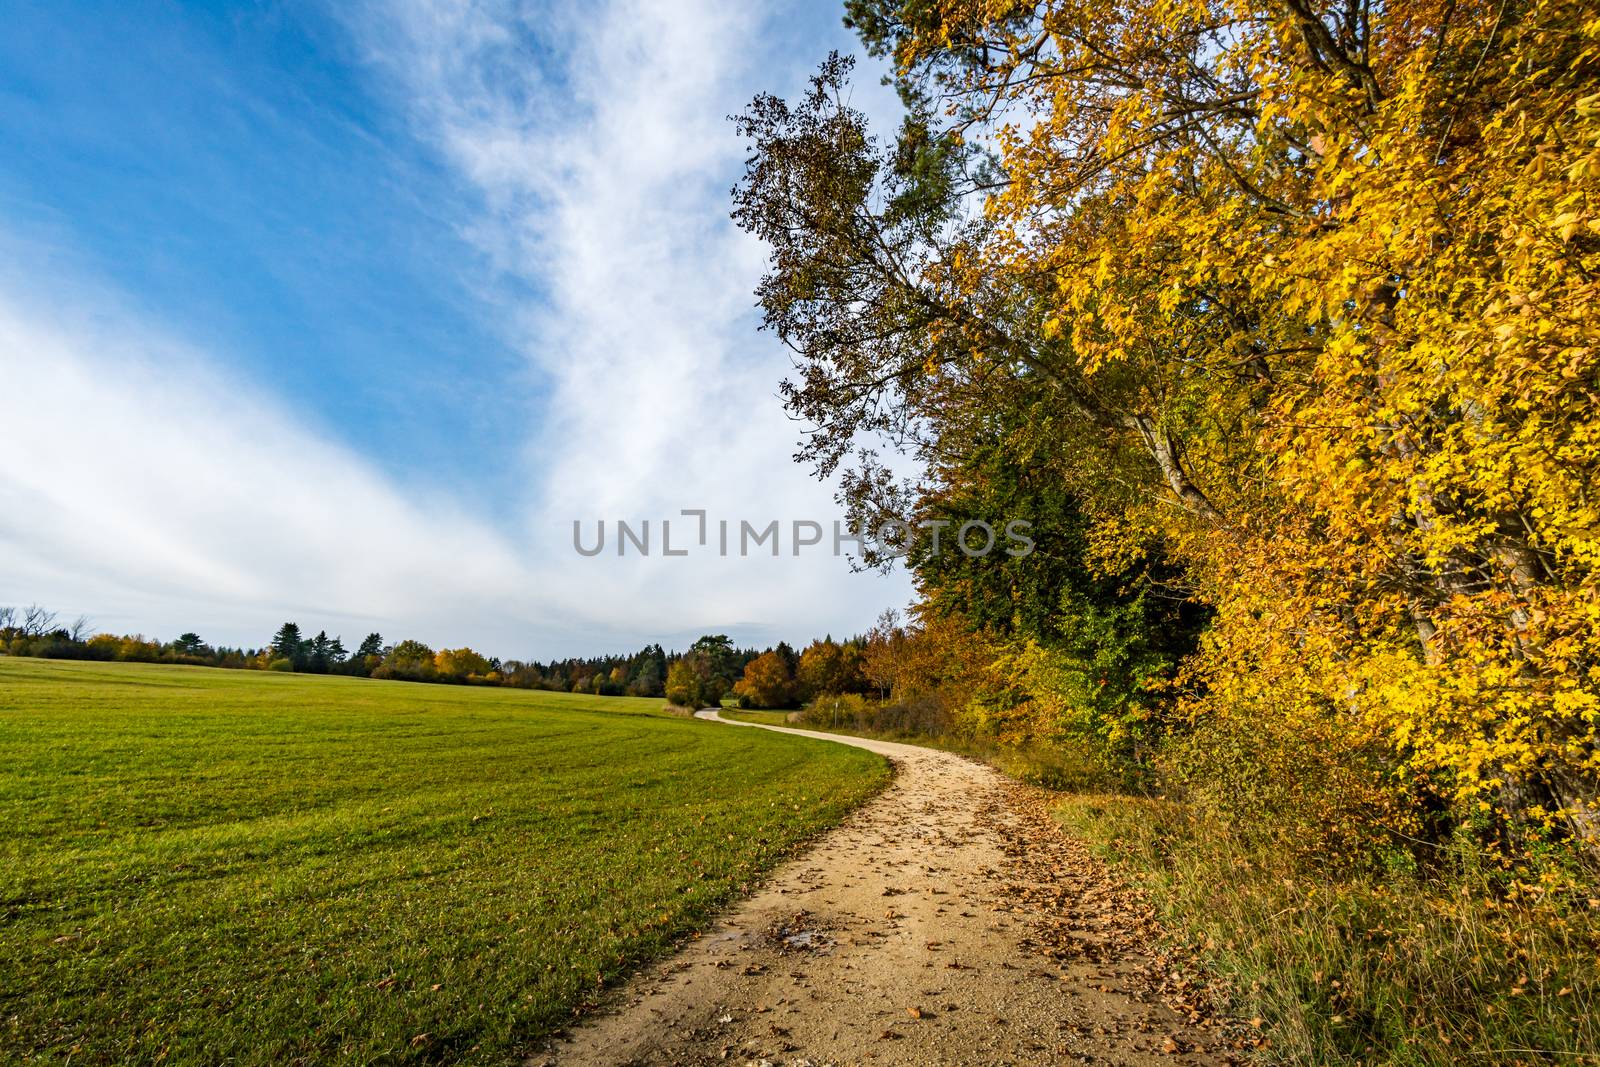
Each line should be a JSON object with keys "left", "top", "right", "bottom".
{"left": 734, "top": 0, "right": 1600, "bottom": 851}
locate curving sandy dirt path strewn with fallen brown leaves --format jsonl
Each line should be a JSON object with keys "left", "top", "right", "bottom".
{"left": 531, "top": 712, "right": 1230, "bottom": 1067}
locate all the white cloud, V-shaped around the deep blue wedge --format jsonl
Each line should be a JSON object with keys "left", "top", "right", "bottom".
{"left": 0, "top": 0, "right": 909, "bottom": 657}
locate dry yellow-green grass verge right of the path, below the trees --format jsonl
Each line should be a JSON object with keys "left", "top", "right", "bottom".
{"left": 1054, "top": 795, "right": 1600, "bottom": 1067}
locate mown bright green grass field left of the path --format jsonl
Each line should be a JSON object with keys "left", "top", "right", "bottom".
{"left": 0, "top": 657, "right": 886, "bottom": 1064}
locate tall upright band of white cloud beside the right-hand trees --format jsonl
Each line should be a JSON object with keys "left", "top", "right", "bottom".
{"left": 337, "top": 0, "right": 909, "bottom": 635}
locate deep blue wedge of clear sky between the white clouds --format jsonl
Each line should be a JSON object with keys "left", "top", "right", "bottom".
{"left": 0, "top": 2, "right": 538, "bottom": 488}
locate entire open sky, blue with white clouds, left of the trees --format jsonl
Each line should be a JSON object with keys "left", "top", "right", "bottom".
{"left": 0, "top": 0, "right": 907, "bottom": 656}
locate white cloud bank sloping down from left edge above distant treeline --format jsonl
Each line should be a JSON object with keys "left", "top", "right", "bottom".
{"left": 0, "top": 299, "right": 569, "bottom": 645}
